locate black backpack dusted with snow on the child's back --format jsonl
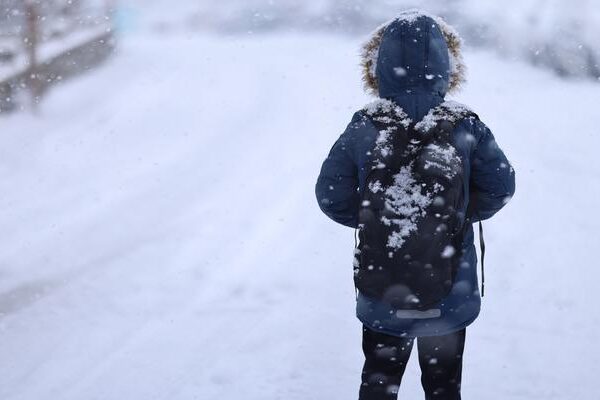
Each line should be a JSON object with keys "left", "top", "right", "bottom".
{"left": 354, "top": 100, "right": 477, "bottom": 310}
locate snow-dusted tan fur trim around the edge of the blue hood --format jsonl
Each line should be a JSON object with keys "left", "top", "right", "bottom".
{"left": 360, "top": 10, "right": 467, "bottom": 96}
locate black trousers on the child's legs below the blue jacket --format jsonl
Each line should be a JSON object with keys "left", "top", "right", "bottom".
{"left": 359, "top": 327, "right": 466, "bottom": 400}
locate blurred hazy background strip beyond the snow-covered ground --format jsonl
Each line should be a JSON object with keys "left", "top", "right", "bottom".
{"left": 0, "top": 0, "right": 600, "bottom": 112}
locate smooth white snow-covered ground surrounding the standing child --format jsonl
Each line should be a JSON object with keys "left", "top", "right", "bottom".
{"left": 0, "top": 34, "right": 600, "bottom": 400}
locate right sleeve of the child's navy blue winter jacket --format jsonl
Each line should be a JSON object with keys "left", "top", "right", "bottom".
{"left": 468, "top": 121, "right": 515, "bottom": 222}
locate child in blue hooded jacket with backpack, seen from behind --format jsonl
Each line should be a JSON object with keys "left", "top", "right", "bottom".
{"left": 316, "top": 11, "right": 515, "bottom": 400}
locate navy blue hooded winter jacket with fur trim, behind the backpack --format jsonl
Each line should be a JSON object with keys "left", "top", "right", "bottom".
{"left": 315, "top": 11, "right": 515, "bottom": 337}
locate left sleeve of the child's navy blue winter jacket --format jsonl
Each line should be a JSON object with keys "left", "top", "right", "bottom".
{"left": 315, "top": 122, "right": 360, "bottom": 228}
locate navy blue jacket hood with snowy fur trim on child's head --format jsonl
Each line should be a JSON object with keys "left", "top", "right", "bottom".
{"left": 361, "top": 10, "right": 466, "bottom": 99}
